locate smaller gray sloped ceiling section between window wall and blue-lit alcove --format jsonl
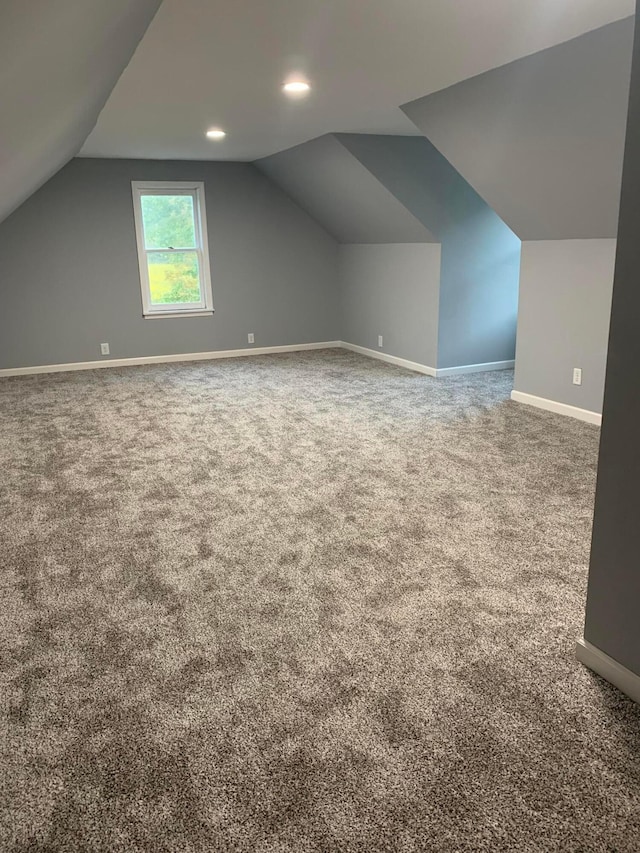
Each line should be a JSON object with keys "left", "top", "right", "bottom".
{"left": 255, "top": 135, "right": 436, "bottom": 243}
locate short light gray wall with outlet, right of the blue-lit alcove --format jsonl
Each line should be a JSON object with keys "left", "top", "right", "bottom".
{"left": 514, "top": 240, "right": 616, "bottom": 412}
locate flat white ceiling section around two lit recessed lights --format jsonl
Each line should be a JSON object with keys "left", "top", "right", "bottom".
{"left": 81, "top": 0, "right": 635, "bottom": 160}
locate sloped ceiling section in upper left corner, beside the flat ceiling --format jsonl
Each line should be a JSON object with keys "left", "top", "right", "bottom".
{"left": 0, "top": 0, "right": 161, "bottom": 221}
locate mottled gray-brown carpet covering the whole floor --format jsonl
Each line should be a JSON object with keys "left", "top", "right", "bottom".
{"left": 0, "top": 350, "right": 640, "bottom": 853}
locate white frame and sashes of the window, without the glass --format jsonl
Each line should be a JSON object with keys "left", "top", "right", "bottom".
{"left": 131, "top": 181, "right": 214, "bottom": 320}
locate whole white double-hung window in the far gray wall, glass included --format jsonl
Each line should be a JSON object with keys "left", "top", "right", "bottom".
{"left": 132, "top": 181, "right": 213, "bottom": 317}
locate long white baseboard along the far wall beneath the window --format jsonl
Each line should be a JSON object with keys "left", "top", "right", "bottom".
{"left": 0, "top": 341, "right": 342, "bottom": 377}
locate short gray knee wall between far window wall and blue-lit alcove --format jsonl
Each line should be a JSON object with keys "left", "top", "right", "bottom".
{"left": 340, "top": 243, "right": 440, "bottom": 367}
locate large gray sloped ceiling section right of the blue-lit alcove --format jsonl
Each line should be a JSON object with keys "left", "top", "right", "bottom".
{"left": 403, "top": 18, "right": 634, "bottom": 240}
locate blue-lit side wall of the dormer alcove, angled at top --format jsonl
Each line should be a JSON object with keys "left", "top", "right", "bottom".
{"left": 337, "top": 134, "right": 520, "bottom": 368}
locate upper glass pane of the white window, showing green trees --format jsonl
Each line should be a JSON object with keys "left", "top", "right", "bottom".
{"left": 140, "top": 195, "right": 197, "bottom": 249}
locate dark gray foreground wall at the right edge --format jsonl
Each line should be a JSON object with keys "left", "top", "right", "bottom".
{"left": 585, "top": 9, "right": 640, "bottom": 676}
